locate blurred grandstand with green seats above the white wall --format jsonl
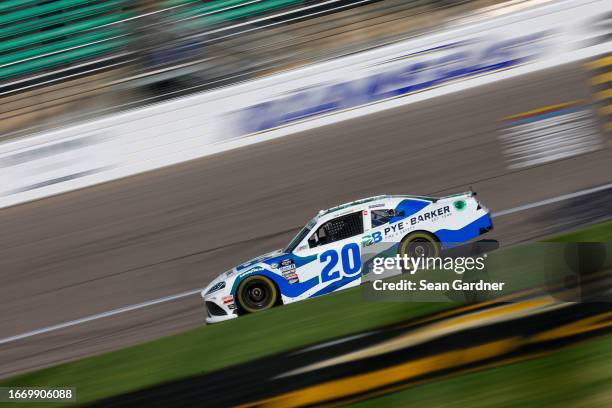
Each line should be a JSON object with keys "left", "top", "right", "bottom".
{"left": 0, "top": 0, "right": 525, "bottom": 138}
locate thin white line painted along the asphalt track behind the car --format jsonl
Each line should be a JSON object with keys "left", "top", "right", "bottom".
{"left": 0, "top": 183, "right": 612, "bottom": 345}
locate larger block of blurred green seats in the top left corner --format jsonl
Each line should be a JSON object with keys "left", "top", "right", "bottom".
{"left": 0, "top": 0, "right": 129, "bottom": 81}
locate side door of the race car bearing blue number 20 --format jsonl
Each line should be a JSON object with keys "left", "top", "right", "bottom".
{"left": 298, "top": 210, "right": 364, "bottom": 297}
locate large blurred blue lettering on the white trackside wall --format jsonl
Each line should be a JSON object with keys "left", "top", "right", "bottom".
{"left": 237, "top": 30, "right": 554, "bottom": 134}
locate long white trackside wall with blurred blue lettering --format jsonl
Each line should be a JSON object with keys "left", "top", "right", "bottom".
{"left": 0, "top": 0, "right": 612, "bottom": 208}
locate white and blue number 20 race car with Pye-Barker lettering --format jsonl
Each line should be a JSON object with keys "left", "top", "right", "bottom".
{"left": 201, "top": 191, "right": 493, "bottom": 323}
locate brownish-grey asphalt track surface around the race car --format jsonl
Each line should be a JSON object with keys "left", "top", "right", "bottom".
{"left": 0, "top": 64, "right": 612, "bottom": 377}
